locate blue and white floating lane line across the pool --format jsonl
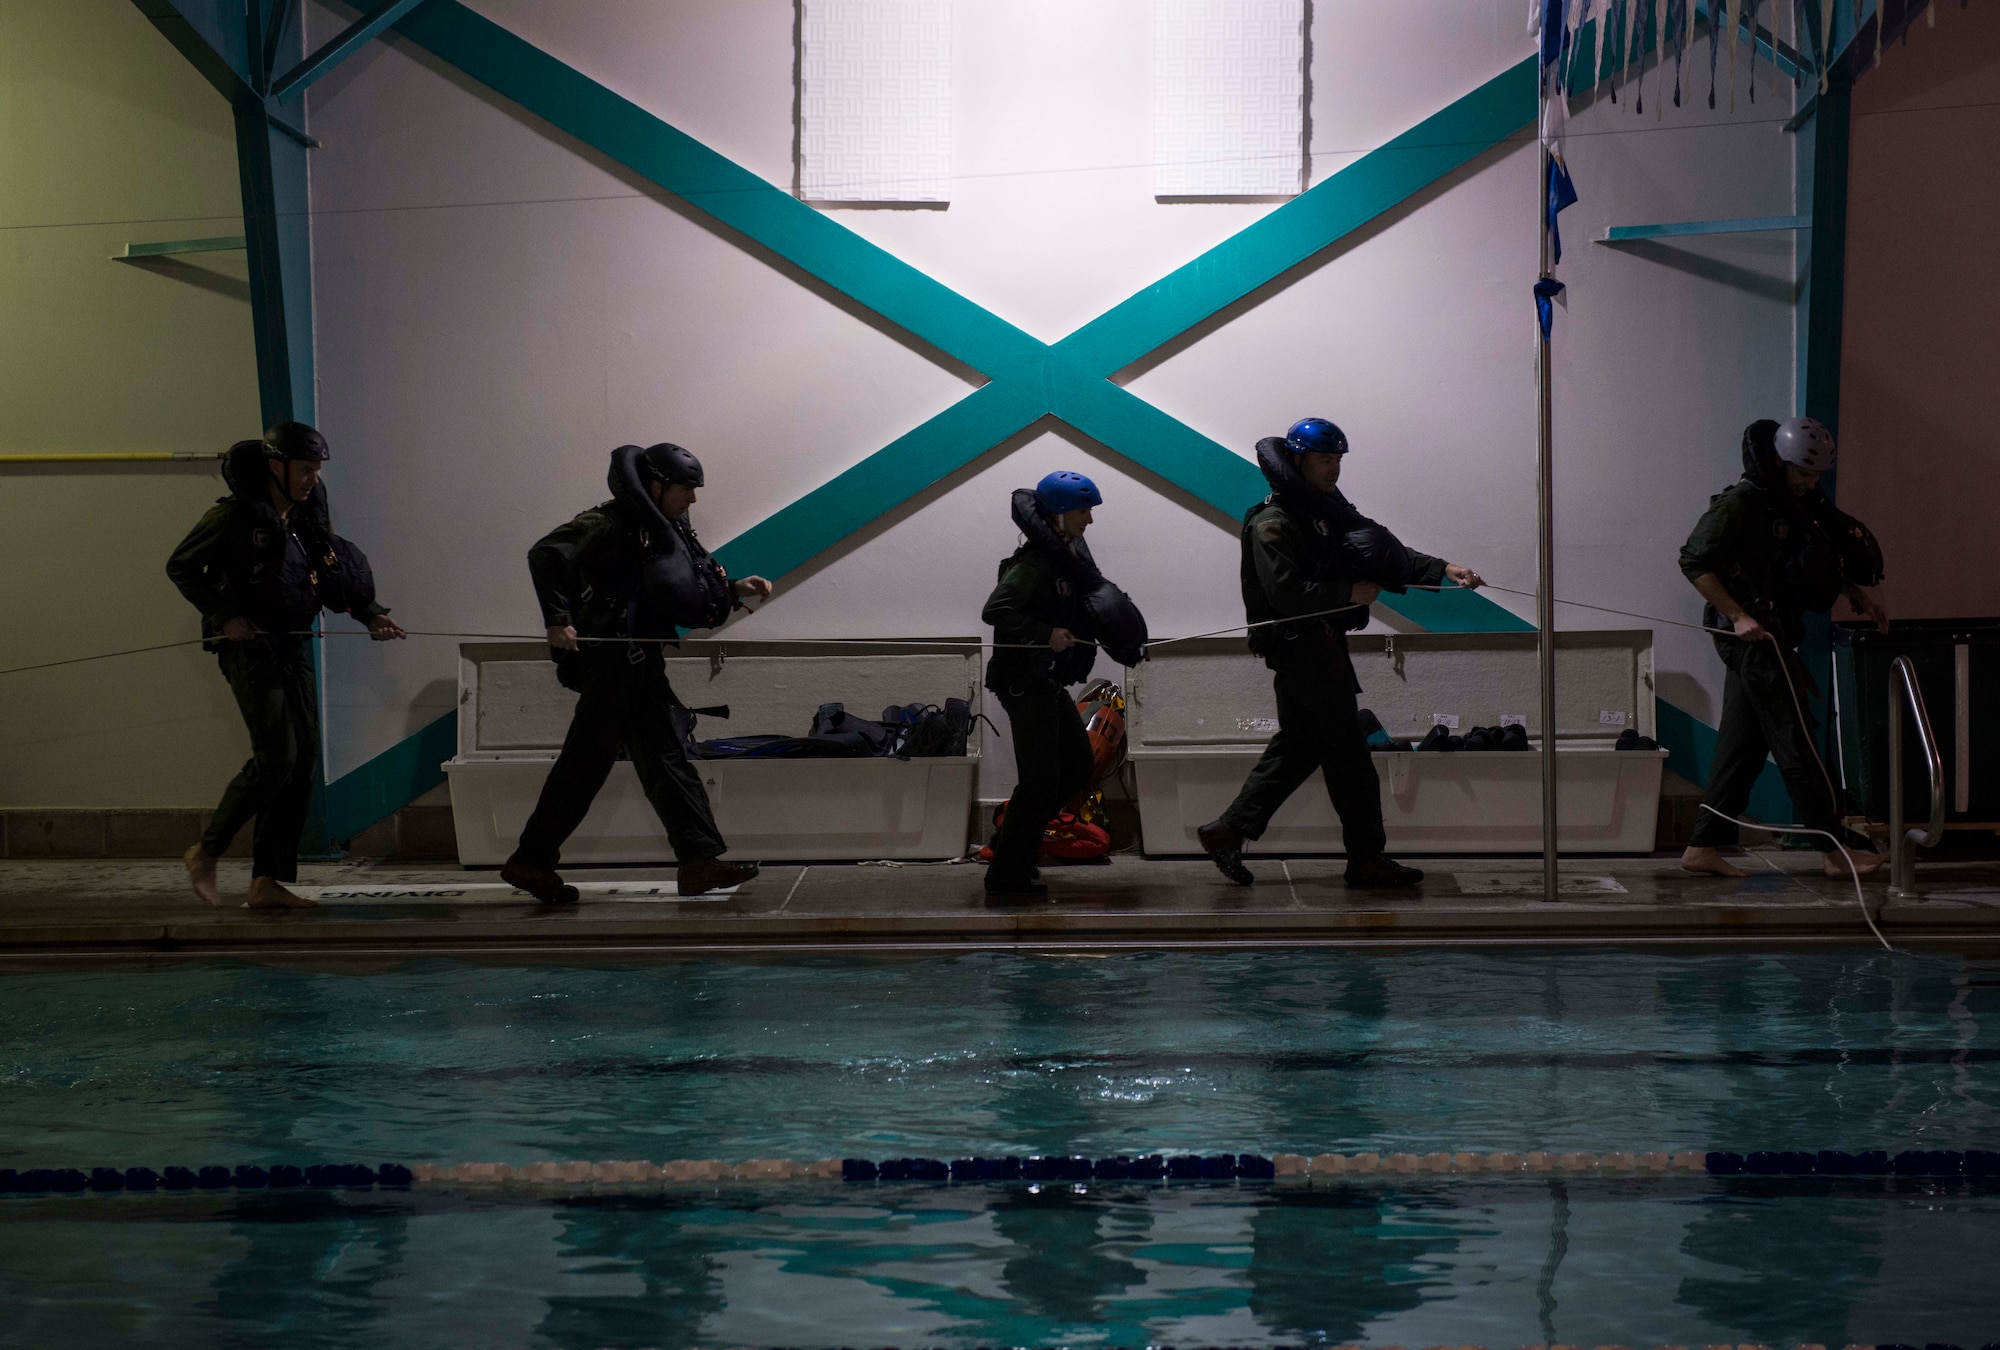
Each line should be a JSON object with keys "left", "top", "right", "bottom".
{"left": 11, "top": 1150, "right": 2000, "bottom": 1196}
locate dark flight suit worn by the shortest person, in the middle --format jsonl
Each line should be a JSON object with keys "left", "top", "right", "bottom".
{"left": 980, "top": 544, "right": 1098, "bottom": 886}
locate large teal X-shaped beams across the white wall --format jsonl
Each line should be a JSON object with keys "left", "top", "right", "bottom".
{"left": 312, "top": 0, "right": 1536, "bottom": 838}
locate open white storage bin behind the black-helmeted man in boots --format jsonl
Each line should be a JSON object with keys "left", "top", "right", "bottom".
{"left": 444, "top": 640, "right": 980, "bottom": 866}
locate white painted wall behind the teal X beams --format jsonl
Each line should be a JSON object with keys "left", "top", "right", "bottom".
{"left": 296, "top": 0, "right": 1792, "bottom": 796}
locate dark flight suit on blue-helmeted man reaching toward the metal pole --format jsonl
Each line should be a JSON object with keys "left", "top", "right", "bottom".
{"left": 1218, "top": 494, "right": 1444, "bottom": 866}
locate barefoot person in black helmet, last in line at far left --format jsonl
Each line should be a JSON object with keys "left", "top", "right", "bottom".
{"left": 166, "top": 422, "right": 404, "bottom": 910}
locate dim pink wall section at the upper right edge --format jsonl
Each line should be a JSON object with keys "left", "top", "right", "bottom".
{"left": 1838, "top": 0, "right": 2000, "bottom": 618}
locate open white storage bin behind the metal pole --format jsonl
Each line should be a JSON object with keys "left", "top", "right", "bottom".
{"left": 1126, "top": 632, "right": 1666, "bottom": 856}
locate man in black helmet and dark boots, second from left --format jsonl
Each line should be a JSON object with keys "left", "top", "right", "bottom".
{"left": 500, "top": 442, "right": 770, "bottom": 904}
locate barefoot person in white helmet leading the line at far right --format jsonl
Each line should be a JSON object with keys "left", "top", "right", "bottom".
{"left": 1680, "top": 418, "right": 1888, "bottom": 876}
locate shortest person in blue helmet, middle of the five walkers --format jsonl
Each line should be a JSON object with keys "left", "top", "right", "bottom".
{"left": 980, "top": 470, "right": 1144, "bottom": 900}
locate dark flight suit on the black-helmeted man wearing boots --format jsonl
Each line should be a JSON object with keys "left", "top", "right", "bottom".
{"left": 508, "top": 502, "right": 728, "bottom": 870}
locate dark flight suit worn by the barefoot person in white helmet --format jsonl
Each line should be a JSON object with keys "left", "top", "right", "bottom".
{"left": 1680, "top": 476, "right": 1842, "bottom": 848}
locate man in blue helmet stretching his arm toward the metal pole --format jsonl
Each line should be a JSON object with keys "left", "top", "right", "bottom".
{"left": 1196, "top": 418, "right": 1482, "bottom": 888}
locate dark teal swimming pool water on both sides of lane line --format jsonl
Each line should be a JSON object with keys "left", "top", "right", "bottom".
{"left": 0, "top": 950, "right": 2000, "bottom": 1346}
